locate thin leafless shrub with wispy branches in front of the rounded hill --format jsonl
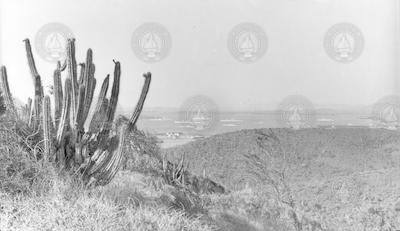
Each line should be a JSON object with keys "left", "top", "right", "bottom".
{"left": 243, "top": 129, "right": 321, "bottom": 231}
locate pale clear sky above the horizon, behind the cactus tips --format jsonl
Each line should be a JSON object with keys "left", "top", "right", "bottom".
{"left": 0, "top": 0, "right": 400, "bottom": 110}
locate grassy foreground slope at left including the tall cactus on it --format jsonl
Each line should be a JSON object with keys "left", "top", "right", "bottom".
{"left": 0, "top": 39, "right": 228, "bottom": 230}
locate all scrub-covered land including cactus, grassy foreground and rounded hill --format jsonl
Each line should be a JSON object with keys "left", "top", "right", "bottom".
{"left": 0, "top": 37, "right": 400, "bottom": 231}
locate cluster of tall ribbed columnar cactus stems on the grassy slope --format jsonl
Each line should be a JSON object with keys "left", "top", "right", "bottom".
{"left": 0, "top": 39, "right": 151, "bottom": 185}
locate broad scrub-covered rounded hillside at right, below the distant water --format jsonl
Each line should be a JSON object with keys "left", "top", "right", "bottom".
{"left": 165, "top": 128, "right": 400, "bottom": 231}
